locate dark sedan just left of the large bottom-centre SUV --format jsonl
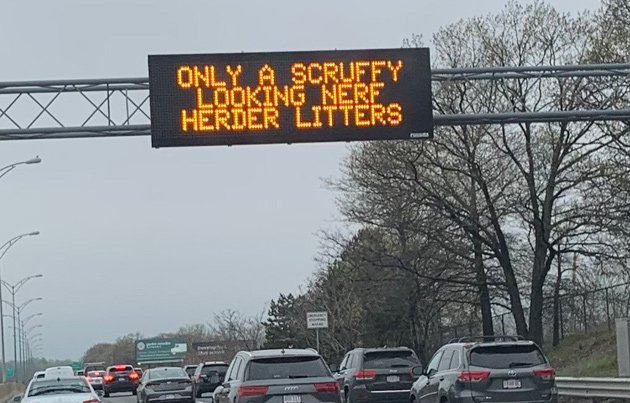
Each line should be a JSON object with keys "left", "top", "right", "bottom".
{"left": 137, "top": 367, "right": 195, "bottom": 403}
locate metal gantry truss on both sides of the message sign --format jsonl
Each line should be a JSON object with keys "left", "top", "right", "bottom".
{"left": 0, "top": 64, "right": 630, "bottom": 140}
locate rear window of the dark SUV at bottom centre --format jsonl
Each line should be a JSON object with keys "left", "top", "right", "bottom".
{"left": 247, "top": 356, "right": 330, "bottom": 381}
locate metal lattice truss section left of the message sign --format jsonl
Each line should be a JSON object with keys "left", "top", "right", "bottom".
{"left": 0, "top": 78, "right": 151, "bottom": 140}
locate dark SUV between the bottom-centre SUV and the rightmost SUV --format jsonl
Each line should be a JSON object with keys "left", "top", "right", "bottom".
{"left": 334, "top": 347, "right": 420, "bottom": 403}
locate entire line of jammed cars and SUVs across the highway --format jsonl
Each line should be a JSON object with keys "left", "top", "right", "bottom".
{"left": 21, "top": 336, "right": 557, "bottom": 403}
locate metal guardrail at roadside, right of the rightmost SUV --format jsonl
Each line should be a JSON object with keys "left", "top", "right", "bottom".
{"left": 556, "top": 377, "right": 630, "bottom": 399}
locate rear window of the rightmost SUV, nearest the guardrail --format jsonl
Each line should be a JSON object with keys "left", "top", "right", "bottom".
{"left": 470, "top": 345, "right": 546, "bottom": 369}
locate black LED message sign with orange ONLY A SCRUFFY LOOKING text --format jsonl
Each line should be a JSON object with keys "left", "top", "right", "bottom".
{"left": 149, "top": 48, "right": 433, "bottom": 147}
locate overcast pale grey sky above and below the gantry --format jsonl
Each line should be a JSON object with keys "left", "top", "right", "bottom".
{"left": 0, "top": 0, "right": 599, "bottom": 358}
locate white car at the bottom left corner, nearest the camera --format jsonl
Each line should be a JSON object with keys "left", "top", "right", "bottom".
{"left": 22, "top": 376, "right": 101, "bottom": 403}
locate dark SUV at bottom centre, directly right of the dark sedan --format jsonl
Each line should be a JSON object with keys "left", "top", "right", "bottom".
{"left": 213, "top": 349, "right": 341, "bottom": 403}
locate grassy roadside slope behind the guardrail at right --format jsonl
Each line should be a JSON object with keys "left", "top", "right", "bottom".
{"left": 545, "top": 328, "right": 617, "bottom": 377}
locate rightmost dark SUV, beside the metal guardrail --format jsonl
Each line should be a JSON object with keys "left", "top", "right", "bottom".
{"left": 411, "top": 336, "right": 558, "bottom": 403}
